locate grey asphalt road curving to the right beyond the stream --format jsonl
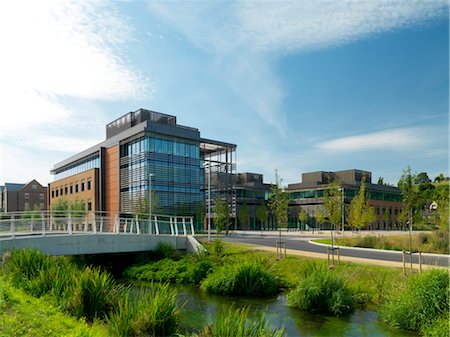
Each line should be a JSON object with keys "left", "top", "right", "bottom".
{"left": 222, "top": 234, "right": 449, "bottom": 266}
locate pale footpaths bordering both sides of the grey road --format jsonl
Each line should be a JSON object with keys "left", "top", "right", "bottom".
{"left": 209, "top": 231, "right": 450, "bottom": 269}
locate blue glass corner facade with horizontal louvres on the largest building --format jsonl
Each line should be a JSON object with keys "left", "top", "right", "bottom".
{"left": 120, "top": 135, "right": 203, "bottom": 215}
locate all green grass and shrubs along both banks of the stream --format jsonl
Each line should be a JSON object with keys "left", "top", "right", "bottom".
{"left": 0, "top": 240, "right": 449, "bottom": 337}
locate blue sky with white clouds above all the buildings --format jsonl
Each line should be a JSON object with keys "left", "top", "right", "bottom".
{"left": 0, "top": 0, "right": 449, "bottom": 185}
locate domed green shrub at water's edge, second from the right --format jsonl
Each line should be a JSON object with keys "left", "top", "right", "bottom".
{"left": 287, "top": 268, "right": 354, "bottom": 316}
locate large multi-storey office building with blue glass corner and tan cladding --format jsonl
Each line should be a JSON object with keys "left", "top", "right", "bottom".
{"left": 49, "top": 109, "right": 236, "bottom": 228}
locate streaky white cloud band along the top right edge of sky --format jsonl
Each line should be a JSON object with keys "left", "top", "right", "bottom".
{"left": 236, "top": 0, "right": 448, "bottom": 52}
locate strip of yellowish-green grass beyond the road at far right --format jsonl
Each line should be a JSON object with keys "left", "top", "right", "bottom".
{"left": 314, "top": 231, "right": 449, "bottom": 254}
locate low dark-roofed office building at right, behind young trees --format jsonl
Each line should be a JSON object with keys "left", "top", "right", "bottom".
{"left": 287, "top": 169, "right": 403, "bottom": 229}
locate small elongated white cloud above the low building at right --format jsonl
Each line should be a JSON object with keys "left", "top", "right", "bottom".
{"left": 316, "top": 128, "right": 430, "bottom": 153}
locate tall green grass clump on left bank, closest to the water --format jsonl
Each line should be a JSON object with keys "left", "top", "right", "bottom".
{"left": 106, "top": 284, "right": 179, "bottom": 337}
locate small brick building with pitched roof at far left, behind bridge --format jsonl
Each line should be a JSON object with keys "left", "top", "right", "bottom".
{"left": 0, "top": 179, "right": 47, "bottom": 212}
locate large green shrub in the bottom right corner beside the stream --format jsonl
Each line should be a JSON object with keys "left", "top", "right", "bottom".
{"left": 381, "top": 269, "right": 449, "bottom": 331}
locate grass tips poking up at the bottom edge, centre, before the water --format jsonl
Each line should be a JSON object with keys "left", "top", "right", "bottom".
{"left": 194, "top": 306, "right": 285, "bottom": 337}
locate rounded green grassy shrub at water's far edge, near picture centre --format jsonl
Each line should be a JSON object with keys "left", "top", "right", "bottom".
{"left": 201, "top": 262, "right": 277, "bottom": 296}
